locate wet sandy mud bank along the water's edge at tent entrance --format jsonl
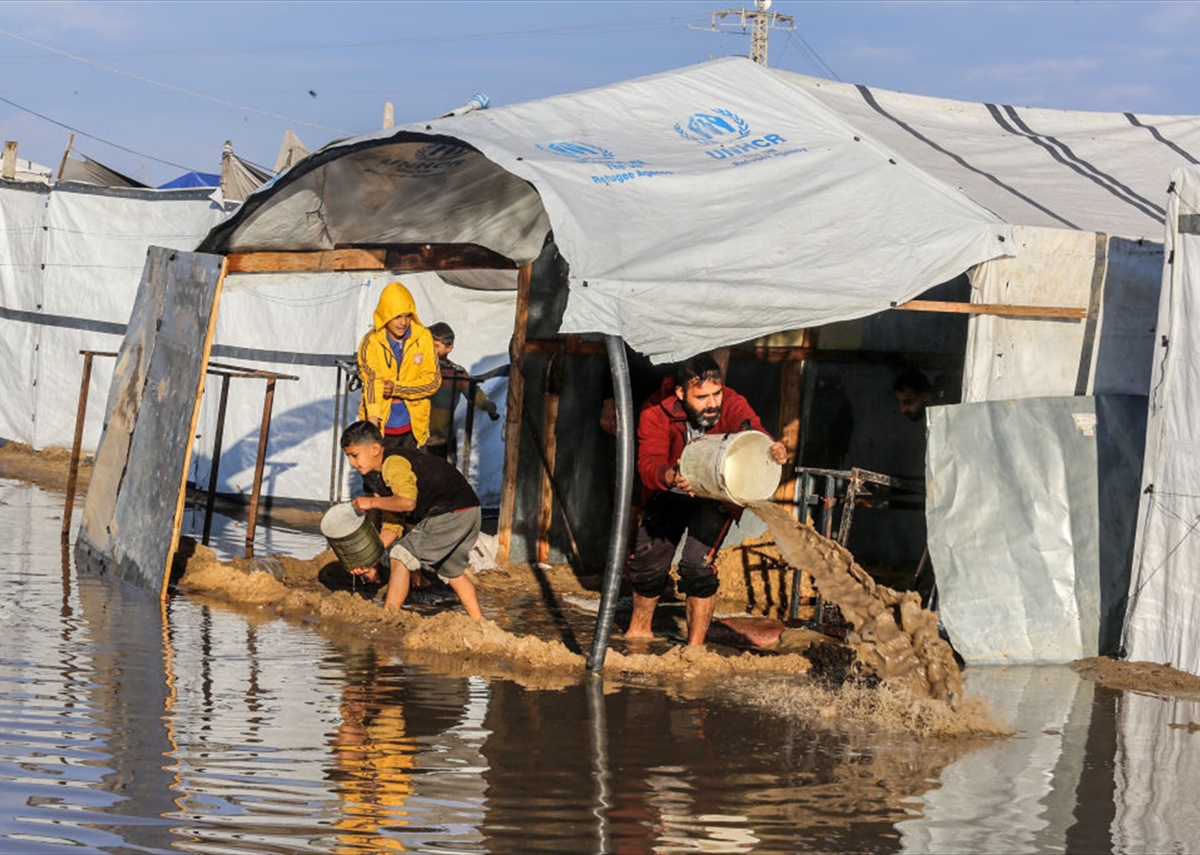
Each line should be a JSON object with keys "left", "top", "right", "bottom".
{"left": 176, "top": 538, "right": 809, "bottom": 686}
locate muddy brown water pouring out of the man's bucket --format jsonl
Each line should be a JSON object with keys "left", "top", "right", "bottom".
{"left": 748, "top": 502, "right": 962, "bottom": 707}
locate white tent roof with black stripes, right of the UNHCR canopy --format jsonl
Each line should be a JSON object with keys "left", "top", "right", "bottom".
{"left": 773, "top": 71, "right": 1200, "bottom": 241}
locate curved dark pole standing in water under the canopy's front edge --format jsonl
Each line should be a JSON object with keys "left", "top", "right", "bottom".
{"left": 588, "top": 335, "right": 634, "bottom": 671}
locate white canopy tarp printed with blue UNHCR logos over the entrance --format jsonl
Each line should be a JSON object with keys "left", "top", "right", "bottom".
{"left": 202, "top": 59, "right": 1012, "bottom": 361}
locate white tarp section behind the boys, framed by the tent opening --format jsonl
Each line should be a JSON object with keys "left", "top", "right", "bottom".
{"left": 195, "top": 271, "right": 516, "bottom": 507}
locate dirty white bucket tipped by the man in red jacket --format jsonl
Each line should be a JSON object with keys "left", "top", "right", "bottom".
{"left": 679, "top": 430, "right": 784, "bottom": 504}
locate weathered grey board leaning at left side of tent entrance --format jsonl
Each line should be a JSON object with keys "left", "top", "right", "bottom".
{"left": 76, "top": 246, "right": 223, "bottom": 598}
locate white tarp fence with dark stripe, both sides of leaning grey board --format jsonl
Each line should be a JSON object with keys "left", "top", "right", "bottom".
{"left": 0, "top": 184, "right": 516, "bottom": 506}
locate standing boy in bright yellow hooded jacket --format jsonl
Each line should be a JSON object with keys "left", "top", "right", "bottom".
{"left": 359, "top": 282, "right": 442, "bottom": 449}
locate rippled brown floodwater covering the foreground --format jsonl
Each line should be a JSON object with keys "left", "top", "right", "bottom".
{"left": 0, "top": 480, "right": 1200, "bottom": 853}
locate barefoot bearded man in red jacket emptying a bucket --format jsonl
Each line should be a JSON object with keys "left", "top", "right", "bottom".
{"left": 625, "top": 353, "right": 787, "bottom": 646}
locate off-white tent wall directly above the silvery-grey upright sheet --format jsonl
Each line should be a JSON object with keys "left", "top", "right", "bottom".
{"left": 962, "top": 227, "right": 1163, "bottom": 402}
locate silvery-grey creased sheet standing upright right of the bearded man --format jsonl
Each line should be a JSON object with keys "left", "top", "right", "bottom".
{"left": 925, "top": 395, "right": 1145, "bottom": 664}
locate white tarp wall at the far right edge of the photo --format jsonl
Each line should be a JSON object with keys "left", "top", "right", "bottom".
{"left": 1124, "top": 167, "right": 1200, "bottom": 675}
